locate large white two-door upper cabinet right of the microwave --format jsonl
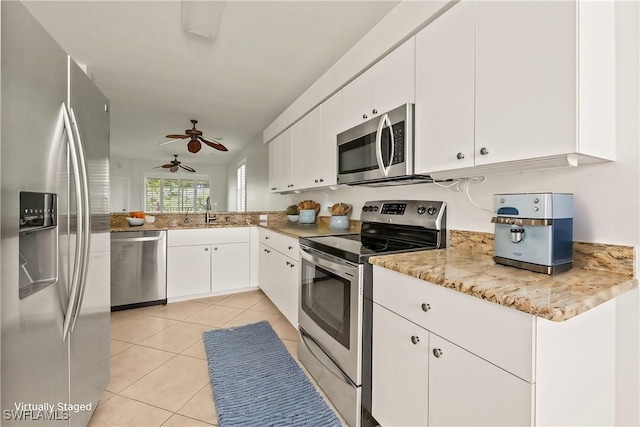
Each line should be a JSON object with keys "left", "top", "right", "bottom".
{"left": 424, "top": 1, "right": 615, "bottom": 178}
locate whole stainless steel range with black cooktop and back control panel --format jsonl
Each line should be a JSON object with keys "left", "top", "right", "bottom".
{"left": 298, "top": 200, "right": 447, "bottom": 427}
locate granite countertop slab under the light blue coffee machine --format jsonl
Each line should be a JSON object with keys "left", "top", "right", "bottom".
{"left": 369, "top": 247, "right": 637, "bottom": 322}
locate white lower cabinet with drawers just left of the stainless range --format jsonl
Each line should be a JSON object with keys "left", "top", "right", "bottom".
{"left": 258, "top": 229, "right": 300, "bottom": 329}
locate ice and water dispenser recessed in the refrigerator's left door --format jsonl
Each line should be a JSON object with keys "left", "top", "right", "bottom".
{"left": 18, "top": 191, "right": 58, "bottom": 299}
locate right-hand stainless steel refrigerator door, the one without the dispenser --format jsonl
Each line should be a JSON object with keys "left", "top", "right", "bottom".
{"left": 69, "top": 60, "right": 111, "bottom": 426}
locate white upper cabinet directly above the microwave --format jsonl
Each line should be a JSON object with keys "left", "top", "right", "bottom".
{"left": 342, "top": 37, "right": 415, "bottom": 130}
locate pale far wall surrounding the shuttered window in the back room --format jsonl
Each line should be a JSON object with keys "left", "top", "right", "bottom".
{"left": 109, "top": 157, "right": 227, "bottom": 211}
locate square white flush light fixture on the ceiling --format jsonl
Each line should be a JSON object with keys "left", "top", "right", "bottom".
{"left": 182, "top": 0, "right": 225, "bottom": 40}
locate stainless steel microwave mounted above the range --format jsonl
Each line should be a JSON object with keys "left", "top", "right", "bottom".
{"left": 337, "top": 104, "right": 432, "bottom": 186}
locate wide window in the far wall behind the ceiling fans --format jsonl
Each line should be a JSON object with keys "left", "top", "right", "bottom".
{"left": 144, "top": 175, "right": 211, "bottom": 212}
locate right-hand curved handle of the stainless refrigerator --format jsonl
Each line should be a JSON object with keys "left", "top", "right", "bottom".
{"left": 70, "top": 107, "right": 91, "bottom": 333}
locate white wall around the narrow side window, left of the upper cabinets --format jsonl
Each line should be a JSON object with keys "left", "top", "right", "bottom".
{"left": 227, "top": 134, "right": 292, "bottom": 211}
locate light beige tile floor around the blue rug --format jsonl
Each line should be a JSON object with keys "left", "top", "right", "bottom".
{"left": 89, "top": 291, "right": 346, "bottom": 427}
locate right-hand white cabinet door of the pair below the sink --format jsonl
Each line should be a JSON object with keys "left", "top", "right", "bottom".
{"left": 211, "top": 243, "right": 249, "bottom": 291}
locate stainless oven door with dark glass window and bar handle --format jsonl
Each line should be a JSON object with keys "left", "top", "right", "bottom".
{"left": 298, "top": 245, "right": 364, "bottom": 386}
